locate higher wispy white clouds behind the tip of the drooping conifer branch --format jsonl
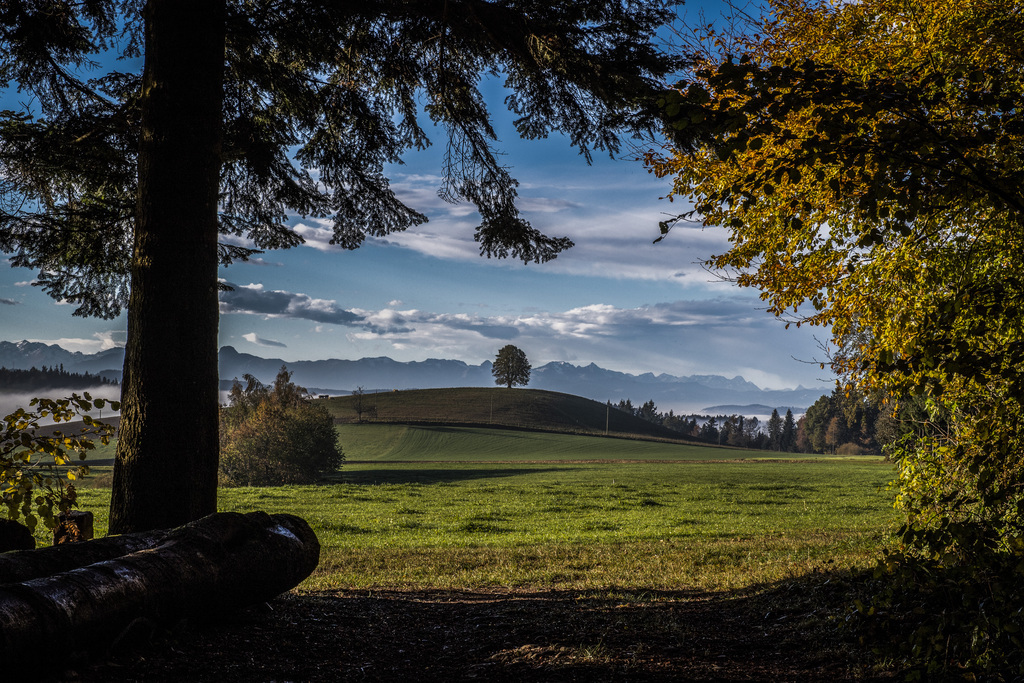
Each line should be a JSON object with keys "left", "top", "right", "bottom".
{"left": 323, "top": 166, "right": 729, "bottom": 291}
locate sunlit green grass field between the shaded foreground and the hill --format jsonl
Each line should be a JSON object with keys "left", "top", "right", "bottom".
{"left": 72, "top": 425, "right": 892, "bottom": 590}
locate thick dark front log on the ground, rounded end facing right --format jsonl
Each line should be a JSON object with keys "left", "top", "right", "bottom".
{"left": 0, "top": 512, "right": 319, "bottom": 674}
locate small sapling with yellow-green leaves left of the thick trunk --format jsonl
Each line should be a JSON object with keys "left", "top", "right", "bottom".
{"left": 0, "top": 392, "right": 120, "bottom": 530}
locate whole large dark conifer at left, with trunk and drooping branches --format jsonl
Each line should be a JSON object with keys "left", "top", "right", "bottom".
{"left": 0, "top": 0, "right": 679, "bottom": 533}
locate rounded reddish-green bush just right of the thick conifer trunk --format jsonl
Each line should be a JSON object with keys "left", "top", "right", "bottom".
{"left": 220, "top": 367, "right": 344, "bottom": 486}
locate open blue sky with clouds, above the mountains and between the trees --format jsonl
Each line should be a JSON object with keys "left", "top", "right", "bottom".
{"left": 0, "top": 2, "right": 830, "bottom": 391}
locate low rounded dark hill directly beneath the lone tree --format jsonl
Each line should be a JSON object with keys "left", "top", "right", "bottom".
{"left": 323, "top": 387, "right": 692, "bottom": 441}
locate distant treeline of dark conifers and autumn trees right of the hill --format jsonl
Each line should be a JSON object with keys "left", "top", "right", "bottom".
{"left": 614, "top": 389, "right": 905, "bottom": 456}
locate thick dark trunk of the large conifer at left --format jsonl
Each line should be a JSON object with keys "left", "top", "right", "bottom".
{"left": 110, "top": 0, "right": 225, "bottom": 533}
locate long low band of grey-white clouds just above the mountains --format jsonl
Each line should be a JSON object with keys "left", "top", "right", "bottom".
{"left": 221, "top": 278, "right": 820, "bottom": 388}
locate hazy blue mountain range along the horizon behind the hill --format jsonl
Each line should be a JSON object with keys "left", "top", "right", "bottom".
{"left": 0, "top": 341, "right": 830, "bottom": 414}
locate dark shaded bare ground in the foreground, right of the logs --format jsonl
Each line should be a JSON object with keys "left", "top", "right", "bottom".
{"left": 66, "top": 577, "right": 891, "bottom": 683}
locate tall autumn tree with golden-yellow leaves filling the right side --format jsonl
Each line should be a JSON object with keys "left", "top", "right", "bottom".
{"left": 647, "top": 0, "right": 1024, "bottom": 676}
